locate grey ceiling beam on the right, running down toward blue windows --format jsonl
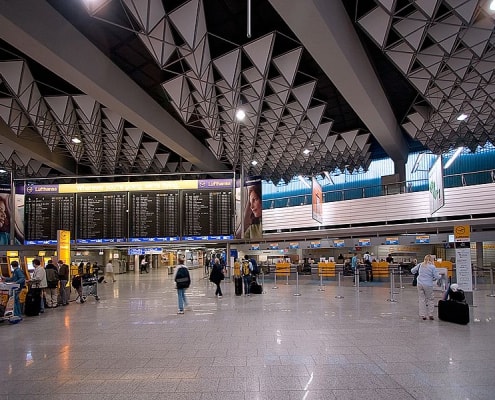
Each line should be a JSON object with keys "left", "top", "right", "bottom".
{"left": 269, "top": 0, "right": 408, "bottom": 163}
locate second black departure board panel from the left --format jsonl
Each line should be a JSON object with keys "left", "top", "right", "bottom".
{"left": 77, "top": 193, "right": 128, "bottom": 243}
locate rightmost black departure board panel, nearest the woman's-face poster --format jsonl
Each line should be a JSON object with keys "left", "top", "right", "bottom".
{"left": 182, "top": 190, "right": 233, "bottom": 240}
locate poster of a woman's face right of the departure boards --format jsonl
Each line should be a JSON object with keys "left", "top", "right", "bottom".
{"left": 235, "top": 177, "right": 263, "bottom": 239}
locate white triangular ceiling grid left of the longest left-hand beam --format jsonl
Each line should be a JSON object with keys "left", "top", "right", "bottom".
{"left": 0, "top": 60, "right": 169, "bottom": 176}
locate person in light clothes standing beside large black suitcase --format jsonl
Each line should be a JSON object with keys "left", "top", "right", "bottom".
{"left": 411, "top": 254, "right": 440, "bottom": 320}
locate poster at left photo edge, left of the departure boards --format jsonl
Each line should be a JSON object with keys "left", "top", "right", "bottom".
{"left": 0, "top": 186, "right": 24, "bottom": 245}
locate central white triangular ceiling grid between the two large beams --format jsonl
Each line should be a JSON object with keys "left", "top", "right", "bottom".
{"left": 89, "top": 0, "right": 369, "bottom": 183}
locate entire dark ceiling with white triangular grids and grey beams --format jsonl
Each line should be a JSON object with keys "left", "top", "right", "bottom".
{"left": 0, "top": 0, "right": 495, "bottom": 184}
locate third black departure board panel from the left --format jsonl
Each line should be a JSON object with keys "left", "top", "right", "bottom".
{"left": 129, "top": 191, "right": 179, "bottom": 242}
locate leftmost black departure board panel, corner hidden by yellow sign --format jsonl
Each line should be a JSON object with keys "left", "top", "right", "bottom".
{"left": 24, "top": 194, "right": 75, "bottom": 244}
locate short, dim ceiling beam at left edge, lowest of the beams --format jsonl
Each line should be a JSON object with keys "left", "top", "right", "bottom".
{"left": 0, "top": 118, "right": 77, "bottom": 175}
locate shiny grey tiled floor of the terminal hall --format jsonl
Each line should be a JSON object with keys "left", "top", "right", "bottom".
{"left": 0, "top": 270, "right": 495, "bottom": 400}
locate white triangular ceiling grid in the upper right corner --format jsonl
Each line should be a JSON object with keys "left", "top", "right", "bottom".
{"left": 357, "top": 0, "right": 495, "bottom": 154}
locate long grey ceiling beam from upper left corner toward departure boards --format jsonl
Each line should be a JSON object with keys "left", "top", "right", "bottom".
{"left": 0, "top": 0, "right": 227, "bottom": 171}
